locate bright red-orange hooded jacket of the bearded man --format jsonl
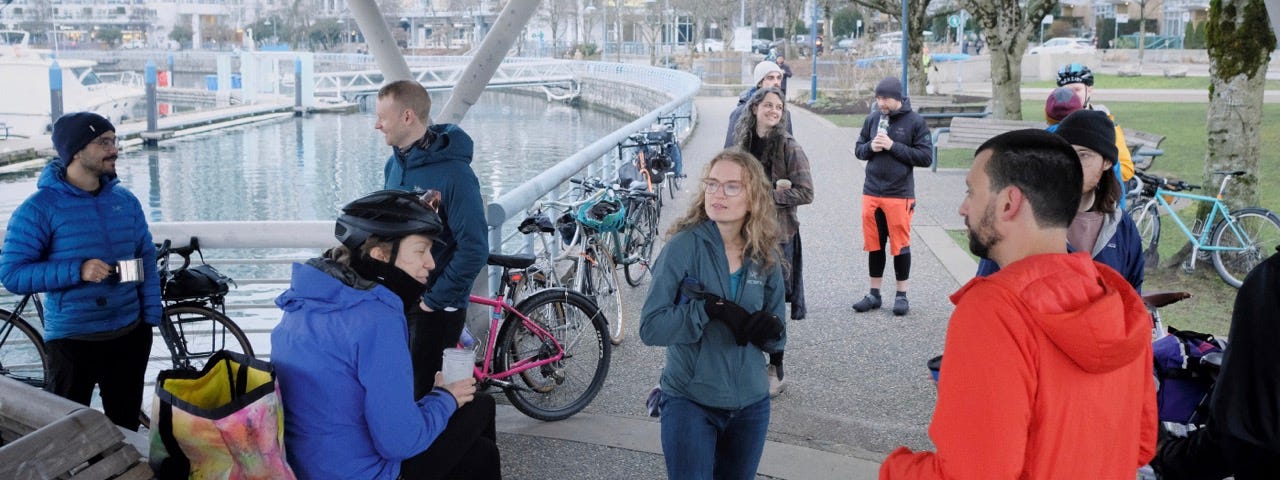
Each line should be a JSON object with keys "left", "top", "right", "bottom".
{"left": 879, "top": 252, "right": 1157, "bottom": 480}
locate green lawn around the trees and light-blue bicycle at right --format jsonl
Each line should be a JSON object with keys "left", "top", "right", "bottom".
{"left": 826, "top": 99, "right": 1280, "bottom": 335}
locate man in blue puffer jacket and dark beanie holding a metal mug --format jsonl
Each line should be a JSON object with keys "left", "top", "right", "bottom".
{"left": 0, "top": 113, "right": 161, "bottom": 430}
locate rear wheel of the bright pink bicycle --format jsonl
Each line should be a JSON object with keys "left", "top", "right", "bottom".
{"left": 494, "top": 288, "right": 613, "bottom": 421}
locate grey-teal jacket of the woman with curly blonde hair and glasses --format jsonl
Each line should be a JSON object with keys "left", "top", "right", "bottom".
{"left": 640, "top": 221, "right": 787, "bottom": 410}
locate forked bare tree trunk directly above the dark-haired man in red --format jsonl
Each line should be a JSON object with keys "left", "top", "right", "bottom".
{"left": 957, "top": 0, "right": 1059, "bottom": 120}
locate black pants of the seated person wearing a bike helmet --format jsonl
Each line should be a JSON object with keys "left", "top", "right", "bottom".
{"left": 401, "top": 394, "right": 502, "bottom": 480}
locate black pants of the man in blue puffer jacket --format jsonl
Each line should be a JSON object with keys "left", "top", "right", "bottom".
{"left": 45, "top": 321, "right": 151, "bottom": 431}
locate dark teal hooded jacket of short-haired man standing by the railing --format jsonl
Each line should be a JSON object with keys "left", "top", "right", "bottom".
{"left": 384, "top": 123, "right": 489, "bottom": 311}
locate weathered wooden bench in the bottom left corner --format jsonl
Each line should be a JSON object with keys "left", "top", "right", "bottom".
{"left": 0, "top": 376, "right": 155, "bottom": 480}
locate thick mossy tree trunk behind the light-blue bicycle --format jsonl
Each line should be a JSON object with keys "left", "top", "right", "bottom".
{"left": 1201, "top": 0, "right": 1276, "bottom": 209}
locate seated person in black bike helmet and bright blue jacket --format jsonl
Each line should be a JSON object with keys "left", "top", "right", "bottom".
{"left": 271, "top": 191, "right": 502, "bottom": 480}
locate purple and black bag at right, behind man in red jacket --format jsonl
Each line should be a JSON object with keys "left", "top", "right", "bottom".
{"left": 1151, "top": 326, "right": 1226, "bottom": 424}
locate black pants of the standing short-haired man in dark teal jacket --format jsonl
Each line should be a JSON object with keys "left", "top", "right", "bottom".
{"left": 407, "top": 308, "right": 467, "bottom": 398}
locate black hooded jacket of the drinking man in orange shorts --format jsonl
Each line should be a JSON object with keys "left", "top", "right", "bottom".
{"left": 854, "top": 99, "right": 933, "bottom": 198}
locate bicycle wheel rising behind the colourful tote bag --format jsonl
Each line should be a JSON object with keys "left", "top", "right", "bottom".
{"left": 147, "top": 305, "right": 253, "bottom": 384}
